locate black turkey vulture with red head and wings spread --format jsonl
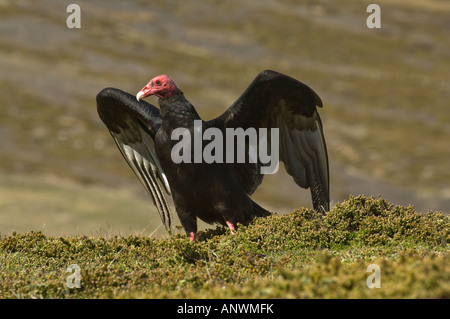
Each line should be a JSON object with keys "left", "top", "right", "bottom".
{"left": 97, "top": 70, "right": 329, "bottom": 241}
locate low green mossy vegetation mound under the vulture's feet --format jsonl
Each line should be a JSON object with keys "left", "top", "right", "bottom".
{"left": 0, "top": 196, "right": 450, "bottom": 298}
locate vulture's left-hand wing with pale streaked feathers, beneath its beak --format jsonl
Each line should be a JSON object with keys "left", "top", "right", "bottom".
{"left": 97, "top": 88, "right": 172, "bottom": 232}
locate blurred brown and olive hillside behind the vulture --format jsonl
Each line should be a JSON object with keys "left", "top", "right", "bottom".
{"left": 0, "top": 0, "right": 450, "bottom": 235}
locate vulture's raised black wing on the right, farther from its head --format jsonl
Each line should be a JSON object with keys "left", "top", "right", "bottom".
{"left": 208, "top": 70, "right": 330, "bottom": 212}
